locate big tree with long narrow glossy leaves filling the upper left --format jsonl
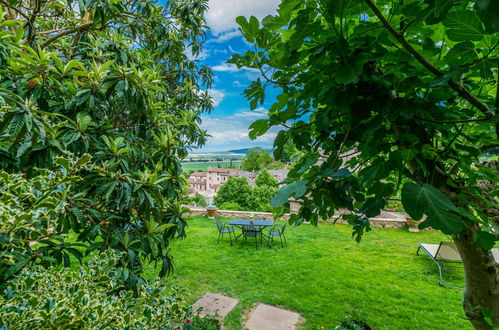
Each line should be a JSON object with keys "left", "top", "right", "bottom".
{"left": 0, "top": 0, "right": 212, "bottom": 288}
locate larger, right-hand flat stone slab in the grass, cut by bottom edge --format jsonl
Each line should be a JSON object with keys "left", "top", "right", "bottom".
{"left": 244, "top": 304, "right": 300, "bottom": 330}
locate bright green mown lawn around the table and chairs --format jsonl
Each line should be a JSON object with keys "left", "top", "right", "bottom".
{"left": 147, "top": 217, "right": 471, "bottom": 329}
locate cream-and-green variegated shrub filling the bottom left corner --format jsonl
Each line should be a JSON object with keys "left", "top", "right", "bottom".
{"left": 0, "top": 253, "right": 191, "bottom": 329}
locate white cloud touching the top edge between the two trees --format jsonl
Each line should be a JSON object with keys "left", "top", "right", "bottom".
{"left": 206, "top": 0, "right": 280, "bottom": 35}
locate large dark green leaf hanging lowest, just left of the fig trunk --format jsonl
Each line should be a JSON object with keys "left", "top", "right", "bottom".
{"left": 402, "top": 182, "right": 464, "bottom": 235}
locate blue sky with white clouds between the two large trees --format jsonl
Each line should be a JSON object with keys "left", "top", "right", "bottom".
{"left": 189, "top": 0, "right": 280, "bottom": 152}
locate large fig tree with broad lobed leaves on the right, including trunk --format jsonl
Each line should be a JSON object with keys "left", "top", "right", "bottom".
{"left": 230, "top": 0, "right": 499, "bottom": 329}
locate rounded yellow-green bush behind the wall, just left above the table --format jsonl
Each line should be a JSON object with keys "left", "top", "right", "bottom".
{"left": 213, "top": 176, "right": 251, "bottom": 210}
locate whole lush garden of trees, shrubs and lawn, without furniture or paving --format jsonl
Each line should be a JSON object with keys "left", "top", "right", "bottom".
{"left": 0, "top": 0, "right": 499, "bottom": 330}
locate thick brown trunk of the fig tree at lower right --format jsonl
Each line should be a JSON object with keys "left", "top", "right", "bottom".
{"left": 454, "top": 225, "right": 499, "bottom": 329}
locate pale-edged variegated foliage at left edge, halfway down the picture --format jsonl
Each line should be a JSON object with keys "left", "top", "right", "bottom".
{"left": 0, "top": 155, "right": 90, "bottom": 282}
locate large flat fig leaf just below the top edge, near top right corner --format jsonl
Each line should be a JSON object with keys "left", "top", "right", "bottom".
{"left": 443, "top": 10, "right": 484, "bottom": 41}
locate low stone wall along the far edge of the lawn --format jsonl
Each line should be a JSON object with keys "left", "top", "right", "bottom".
{"left": 184, "top": 205, "right": 407, "bottom": 228}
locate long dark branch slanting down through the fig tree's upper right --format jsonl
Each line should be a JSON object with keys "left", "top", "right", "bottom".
{"left": 364, "top": 0, "right": 493, "bottom": 119}
